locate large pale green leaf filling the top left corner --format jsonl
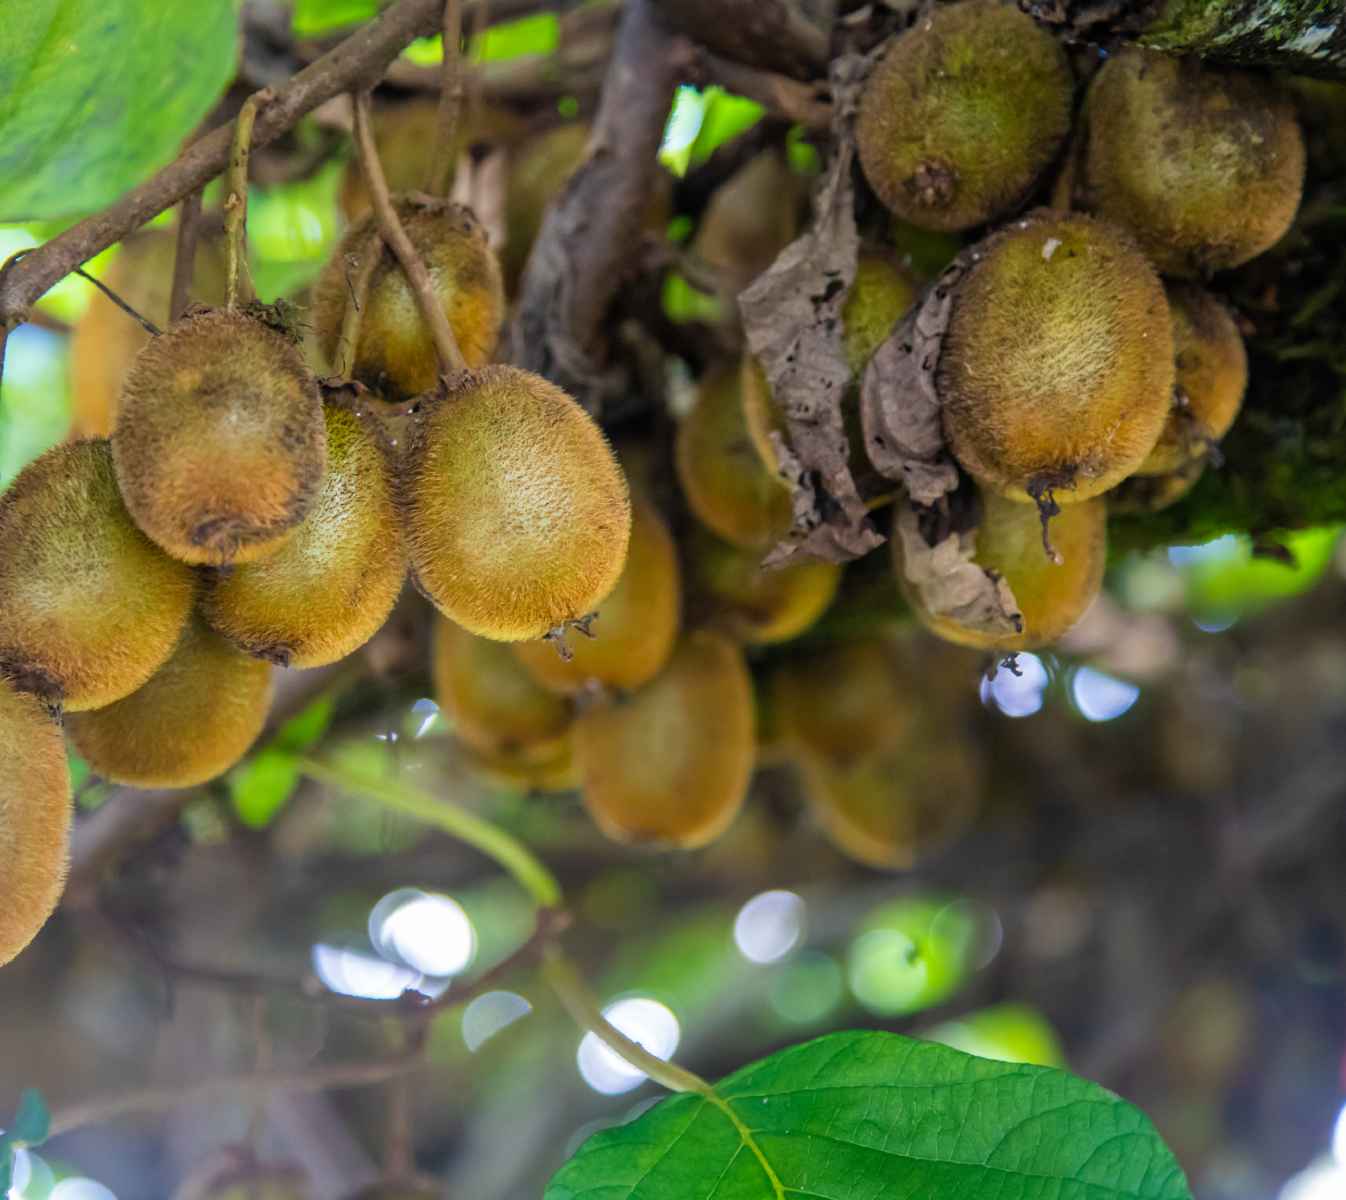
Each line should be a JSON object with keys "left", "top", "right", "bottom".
{"left": 0, "top": 0, "right": 237, "bottom": 221}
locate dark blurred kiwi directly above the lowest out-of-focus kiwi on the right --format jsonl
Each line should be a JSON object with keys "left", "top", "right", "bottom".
{"left": 770, "top": 637, "right": 920, "bottom": 765}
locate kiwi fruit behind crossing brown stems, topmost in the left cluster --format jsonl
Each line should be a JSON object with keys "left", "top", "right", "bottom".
{"left": 312, "top": 192, "right": 505, "bottom": 400}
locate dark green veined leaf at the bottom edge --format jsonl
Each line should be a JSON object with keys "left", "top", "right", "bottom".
{"left": 545, "top": 1033, "right": 1191, "bottom": 1200}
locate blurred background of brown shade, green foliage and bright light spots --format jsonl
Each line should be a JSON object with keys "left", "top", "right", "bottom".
{"left": 0, "top": 3, "right": 1346, "bottom": 1200}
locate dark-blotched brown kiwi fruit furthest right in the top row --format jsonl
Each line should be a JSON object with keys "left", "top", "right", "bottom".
{"left": 1075, "top": 47, "right": 1304, "bottom": 277}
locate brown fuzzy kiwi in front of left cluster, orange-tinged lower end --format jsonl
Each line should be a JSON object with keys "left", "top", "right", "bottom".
{"left": 112, "top": 309, "right": 327, "bottom": 566}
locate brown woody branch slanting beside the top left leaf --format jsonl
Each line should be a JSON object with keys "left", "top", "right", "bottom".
{"left": 0, "top": 0, "right": 537, "bottom": 328}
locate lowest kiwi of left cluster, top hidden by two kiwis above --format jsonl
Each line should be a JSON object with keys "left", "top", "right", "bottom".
{"left": 66, "top": 617, "right": 272, "bottom": 787}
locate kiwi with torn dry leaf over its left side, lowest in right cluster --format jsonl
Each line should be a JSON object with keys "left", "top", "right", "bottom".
{"left": 892, "top": 491, "right": 1108, "bottom": 654}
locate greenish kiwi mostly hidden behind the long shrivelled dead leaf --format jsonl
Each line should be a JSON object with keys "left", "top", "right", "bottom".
{"left": 742, "top": 248, "right": 917, "bottom": 476}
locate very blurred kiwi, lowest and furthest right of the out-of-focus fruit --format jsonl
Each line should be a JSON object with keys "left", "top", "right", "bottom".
{"left": 802, "top": 725, "right": 981, "bottom": 870}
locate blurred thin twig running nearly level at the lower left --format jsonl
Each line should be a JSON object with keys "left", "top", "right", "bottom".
{"left": 51, "top": 1053, "right": 423, "bottom": 1137}
